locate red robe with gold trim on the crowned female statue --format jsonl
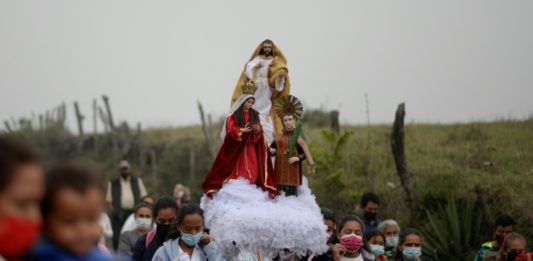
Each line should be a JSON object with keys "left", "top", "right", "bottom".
{"left": 202, "top": 111, "right": 277, "bottom": 196}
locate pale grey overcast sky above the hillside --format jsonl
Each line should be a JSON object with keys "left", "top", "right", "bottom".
{"left": 0, "top": 0, "right": 533, "bottom": 130}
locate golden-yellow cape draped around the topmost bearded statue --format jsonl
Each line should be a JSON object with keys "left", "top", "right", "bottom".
{"left": 231, "top": 39, "right": 290, "bottom": 138}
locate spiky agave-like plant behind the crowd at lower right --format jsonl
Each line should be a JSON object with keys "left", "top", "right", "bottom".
{"left": 422, "top": 197, "right": 481, "bottom": 261}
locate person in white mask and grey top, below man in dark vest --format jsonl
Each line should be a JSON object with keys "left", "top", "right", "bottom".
{"left": 118, "top": 203, "right": 153, "bottom": 257}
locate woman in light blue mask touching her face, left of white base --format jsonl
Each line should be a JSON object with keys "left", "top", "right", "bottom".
{"left": 152, "top": 204, "right": 226, "bottom": 261}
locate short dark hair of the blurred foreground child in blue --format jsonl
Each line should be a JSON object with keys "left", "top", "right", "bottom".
{"left": 42, "top": 164, "right": 105, "bottom": 217}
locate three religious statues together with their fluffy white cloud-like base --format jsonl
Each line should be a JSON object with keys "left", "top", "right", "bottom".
{"left": 201, "top": 40, "right": 328, "bottom": 260}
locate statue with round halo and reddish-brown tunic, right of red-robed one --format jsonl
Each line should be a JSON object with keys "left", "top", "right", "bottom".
{"left": 270, "top": 95, "right": 315, "bottom": 196}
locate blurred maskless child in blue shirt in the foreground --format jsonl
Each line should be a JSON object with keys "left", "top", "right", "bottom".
{"left": 29, "top": 165, "right": 111, "bottom": 261}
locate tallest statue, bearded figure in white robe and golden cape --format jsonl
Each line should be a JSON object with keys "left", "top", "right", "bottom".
{"left": 231, "top": 39, "right": 290, "bottom": 144}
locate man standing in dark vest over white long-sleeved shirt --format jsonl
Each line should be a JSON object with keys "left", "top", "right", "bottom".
{"left": 106, "top": 160, "right": 147, "bottom": 249}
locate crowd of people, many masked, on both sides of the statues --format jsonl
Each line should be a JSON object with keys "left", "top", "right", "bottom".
{"left": 0, "top": 137, "right": 531, "bottom": 261}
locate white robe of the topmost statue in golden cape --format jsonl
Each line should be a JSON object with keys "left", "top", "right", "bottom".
{"left": 246, "top": 56, "right": 285, "bottom": 144}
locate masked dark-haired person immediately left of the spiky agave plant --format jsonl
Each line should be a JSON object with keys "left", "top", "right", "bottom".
{"left": 394, "top": 228, "right": 432, "bottom": 261}
